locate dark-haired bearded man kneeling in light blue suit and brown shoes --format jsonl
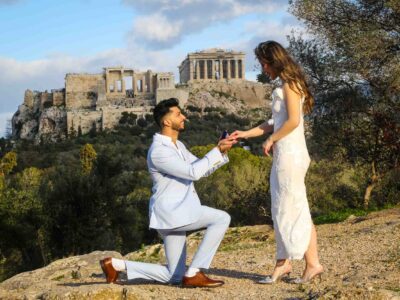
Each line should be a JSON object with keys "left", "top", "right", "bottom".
{"left": 100, "top": 98, "right": 236, "bottom": 287}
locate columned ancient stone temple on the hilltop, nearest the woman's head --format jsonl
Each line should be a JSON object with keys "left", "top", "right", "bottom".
{"left": 179, "top": 48, "right": 245, "bottom": 83}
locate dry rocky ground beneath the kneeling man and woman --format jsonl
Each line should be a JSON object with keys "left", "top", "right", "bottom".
{"left": 0, "top": 207, "right": 400, "bottom": 299}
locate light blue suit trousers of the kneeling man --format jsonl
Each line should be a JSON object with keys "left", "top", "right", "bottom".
{"left": 125, "top": 206, "right": 231, "bottom": 284}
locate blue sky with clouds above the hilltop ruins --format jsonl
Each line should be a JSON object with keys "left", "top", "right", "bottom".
{"left": 0, "top": 0, "right": 305, "bottom": 136}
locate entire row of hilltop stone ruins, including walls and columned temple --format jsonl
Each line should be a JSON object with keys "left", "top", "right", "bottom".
{"left": 12, "top": 48, "right": 263, "bottom": 142}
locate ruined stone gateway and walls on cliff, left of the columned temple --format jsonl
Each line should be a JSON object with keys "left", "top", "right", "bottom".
{"left": 12, "top": 67, "right": 188, "bottom": 140}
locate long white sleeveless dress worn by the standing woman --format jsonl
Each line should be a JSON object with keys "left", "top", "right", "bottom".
{"left": 270, "top": 88, "right": 312, "bottom": 259}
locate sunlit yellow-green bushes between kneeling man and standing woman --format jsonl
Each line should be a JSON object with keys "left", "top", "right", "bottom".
{"left": 191, "top": 145, "right": 271, "bottom": 226}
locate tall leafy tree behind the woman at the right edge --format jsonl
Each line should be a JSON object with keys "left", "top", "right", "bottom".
{"left": 289, "top": 0, "right": 400, "bottom": 208}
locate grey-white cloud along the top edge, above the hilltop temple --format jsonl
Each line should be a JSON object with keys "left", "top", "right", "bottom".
{"left": 124, "top": 0, "right": 288, "bottom": 49}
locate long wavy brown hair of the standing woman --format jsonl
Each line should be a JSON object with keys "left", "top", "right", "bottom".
{"left": 254, "top": 41, "right": 314, "bottom": 114}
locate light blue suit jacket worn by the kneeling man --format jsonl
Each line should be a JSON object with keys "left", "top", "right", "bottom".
{"left": 147, "top": 133, "right": 229, "bottom": 229}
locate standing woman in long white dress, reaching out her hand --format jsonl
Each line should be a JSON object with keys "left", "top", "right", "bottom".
{"left": 232, "top": 41, "right": 323, "bottom": 283}
